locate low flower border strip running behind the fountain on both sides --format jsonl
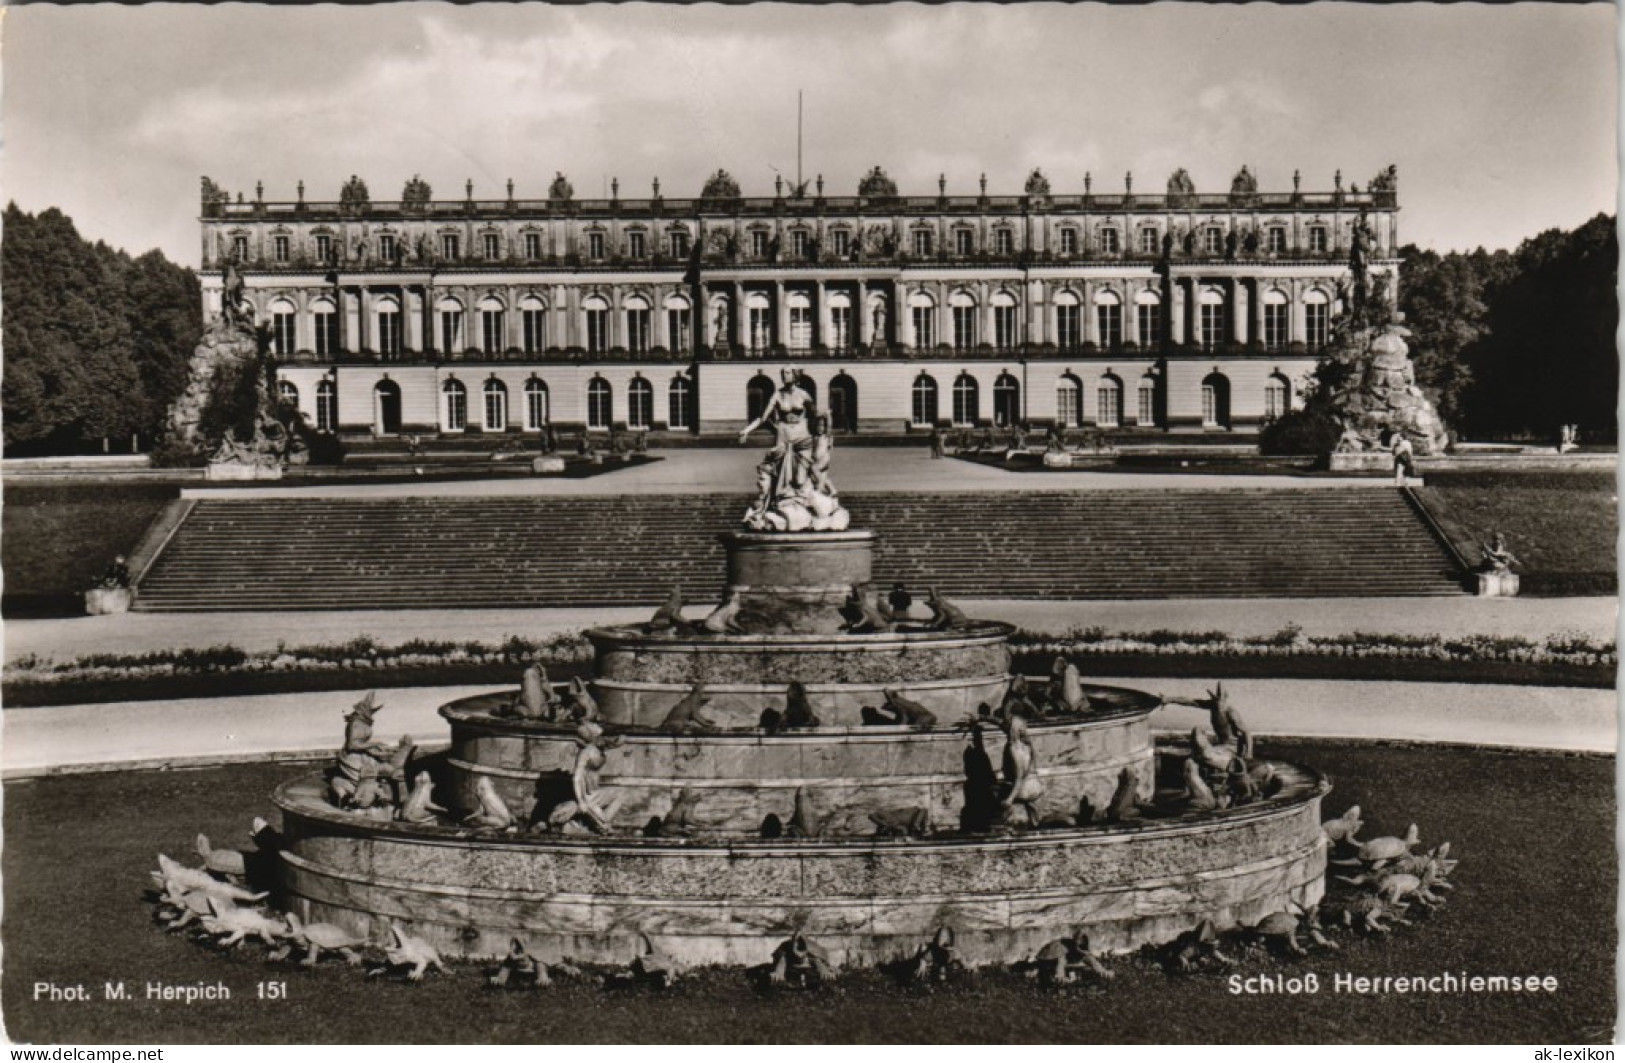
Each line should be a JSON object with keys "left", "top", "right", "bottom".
{"left": 3, "top": 626, "right": 1619, "bottom": 709}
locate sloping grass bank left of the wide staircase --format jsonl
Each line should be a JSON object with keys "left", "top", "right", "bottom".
{"left": 0, "top": 483, "right": 180, "bottom": 619}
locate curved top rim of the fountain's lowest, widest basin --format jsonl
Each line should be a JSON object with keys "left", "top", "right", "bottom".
{"left": 271, "top": 761, "right": 1331, "bottom": 858}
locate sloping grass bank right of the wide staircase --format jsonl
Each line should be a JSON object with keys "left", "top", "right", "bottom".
{"left": 1417, "top": 470, "right": 1619, "bottom": 597}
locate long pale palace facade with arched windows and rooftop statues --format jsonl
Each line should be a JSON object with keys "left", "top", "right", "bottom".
{"left": 202, "top": 167, "right": 1399, "bottom": 436}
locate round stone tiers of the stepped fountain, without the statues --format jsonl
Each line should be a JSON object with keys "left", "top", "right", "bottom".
{"left": 276, "top": 383, "right": 1326, "bottom": 964}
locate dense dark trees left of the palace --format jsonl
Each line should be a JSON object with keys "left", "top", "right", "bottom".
{"left": 0, "top": 203, "right": 203, "bottom": 455}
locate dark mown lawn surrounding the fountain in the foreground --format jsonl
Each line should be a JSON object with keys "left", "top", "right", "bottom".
{"left": 0, "top": 740, "right": 1617, "bottom": 1043}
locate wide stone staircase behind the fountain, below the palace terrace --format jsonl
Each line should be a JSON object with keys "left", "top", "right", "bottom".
{"left": 137, "top": 488, "right": 1461, "bottom": 611}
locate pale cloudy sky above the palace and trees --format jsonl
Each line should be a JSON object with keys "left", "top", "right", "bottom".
{"left": 0, "top": 3, "right": 1617, "bottom": 265}
